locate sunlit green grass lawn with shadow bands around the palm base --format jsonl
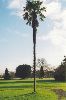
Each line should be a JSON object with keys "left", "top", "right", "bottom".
{"left": 0, "top": 79, "right": 66, "bottom": 100}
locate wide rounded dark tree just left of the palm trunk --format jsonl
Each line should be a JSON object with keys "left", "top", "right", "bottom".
{"left": 15, "top": 64, "right": 31, "bottom": 79}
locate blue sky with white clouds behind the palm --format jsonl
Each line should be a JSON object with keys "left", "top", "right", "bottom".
{"left": 0, "top": 0, "right": 66, "bottom": 73}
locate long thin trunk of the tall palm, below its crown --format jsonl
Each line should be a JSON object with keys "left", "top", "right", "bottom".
{"left": 33, "top": 27, "right": 36, "bottom": 92}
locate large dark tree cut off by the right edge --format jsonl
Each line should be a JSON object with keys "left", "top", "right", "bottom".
{"left": 54, "top": 56, "right": 66, "bottom": 81}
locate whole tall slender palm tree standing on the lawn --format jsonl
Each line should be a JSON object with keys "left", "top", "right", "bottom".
{"left": 23, "top": 0, "right": 46, "bottom": 92}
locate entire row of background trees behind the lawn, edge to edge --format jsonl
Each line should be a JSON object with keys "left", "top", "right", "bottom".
{"left": 0, "top": 56, "right": 66, "bottom": 81}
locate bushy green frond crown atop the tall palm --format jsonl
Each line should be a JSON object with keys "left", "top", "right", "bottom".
{"left": 23, "top": 0, "right": 46, "bottom": 27}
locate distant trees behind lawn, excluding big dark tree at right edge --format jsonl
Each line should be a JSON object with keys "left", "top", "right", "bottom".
{"left": 1, "top": 58, "right": 53, "bottom": 80}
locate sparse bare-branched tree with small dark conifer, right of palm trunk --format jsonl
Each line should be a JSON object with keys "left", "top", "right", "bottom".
{"left": 37, "top": 58, "right": 54, "bottom": 78}
